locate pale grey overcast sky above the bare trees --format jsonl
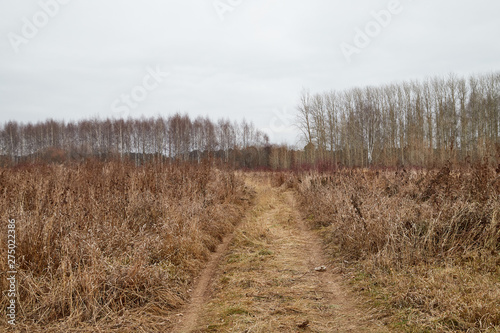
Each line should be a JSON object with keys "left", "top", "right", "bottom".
{"left": 0, "top": 0, "right": 500, "bottom": 143}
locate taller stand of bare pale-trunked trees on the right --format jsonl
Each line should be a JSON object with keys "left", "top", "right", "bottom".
{"left": 297, "top": 72, "right": 500, "bottom": 167}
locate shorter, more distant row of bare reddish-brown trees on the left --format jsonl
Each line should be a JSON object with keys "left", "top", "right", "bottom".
{"left": 0, "top": 113, "right": 269, "bottom": 167}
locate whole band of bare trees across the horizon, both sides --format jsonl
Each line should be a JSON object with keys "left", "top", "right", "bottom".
{"left": 0, "top": 72, "right": 500, "bottom": 169}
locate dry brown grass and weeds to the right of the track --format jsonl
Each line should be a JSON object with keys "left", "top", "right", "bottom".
{"left": 286, "top": 165, "right": 500, "bottom": 332}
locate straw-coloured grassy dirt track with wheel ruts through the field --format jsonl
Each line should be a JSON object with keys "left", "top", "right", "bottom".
{"left": 174, "top": 177, "right": 389, "bottom": 333}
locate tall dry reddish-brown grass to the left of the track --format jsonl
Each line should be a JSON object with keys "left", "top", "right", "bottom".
{"left": 0, "top": 161, "right": 249, "bottom": 332}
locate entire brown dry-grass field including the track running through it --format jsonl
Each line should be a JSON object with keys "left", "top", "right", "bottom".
{"left": 0, "top": 161, "right": 500, "bottom": 332}
